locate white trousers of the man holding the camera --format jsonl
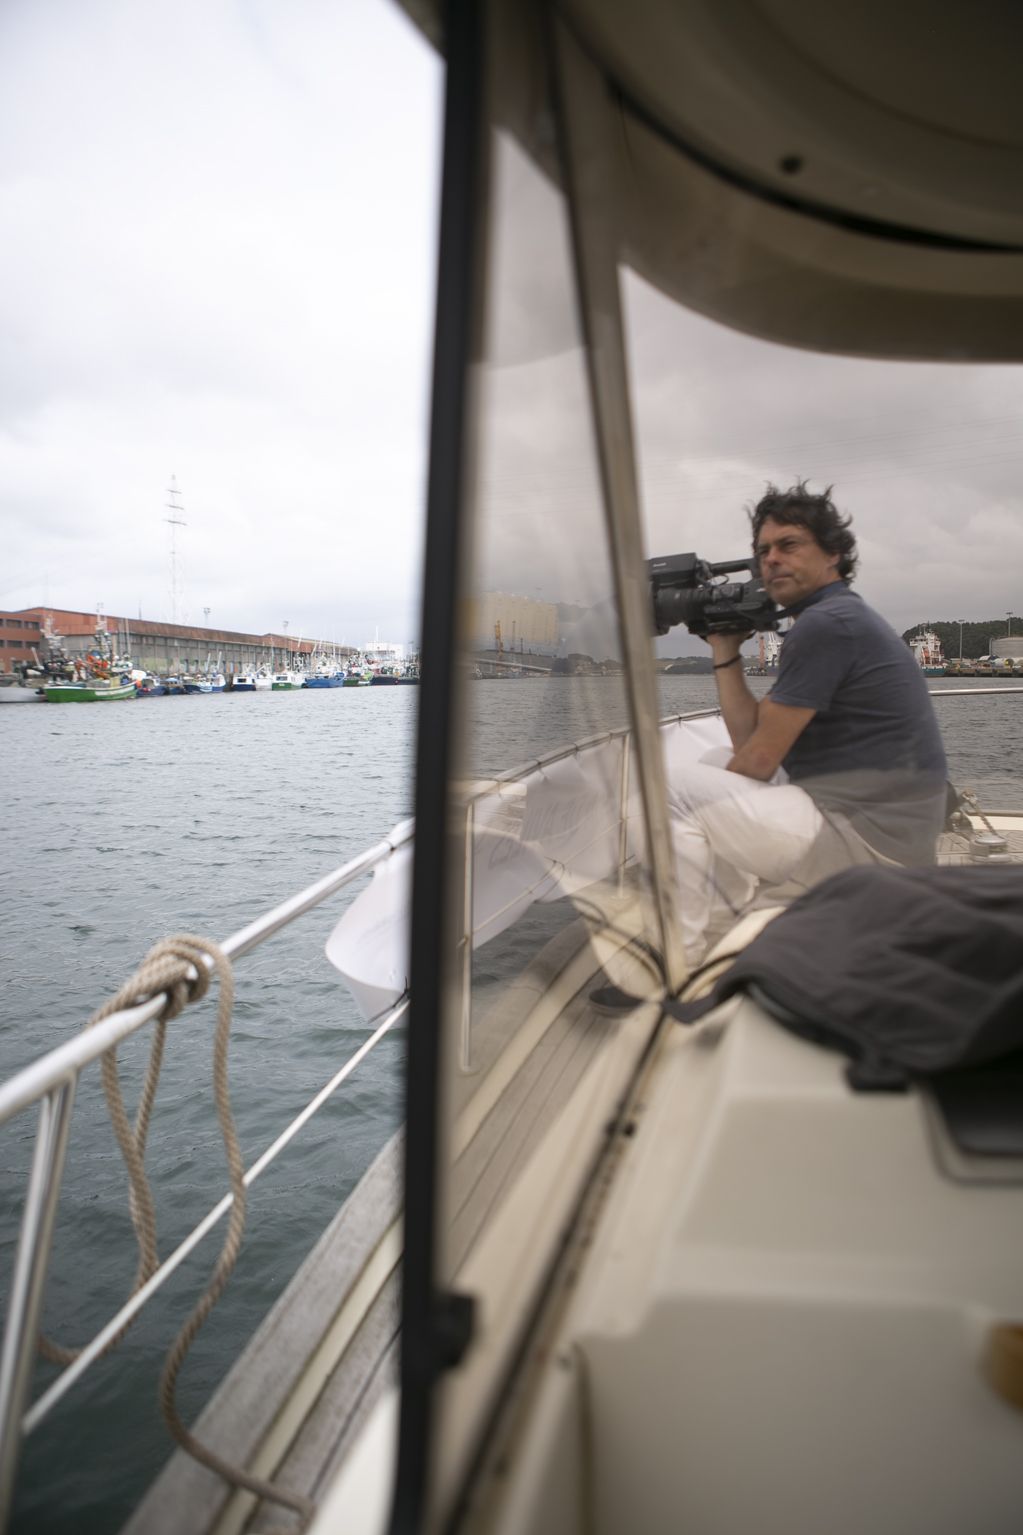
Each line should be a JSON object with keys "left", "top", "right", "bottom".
{"left": 668, "top": 748, "right": 825, "bottom": 964}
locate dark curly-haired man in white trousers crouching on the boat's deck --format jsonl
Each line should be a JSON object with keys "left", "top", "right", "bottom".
{"left": 670, "top": 482, "right": 946, "bottom": 959}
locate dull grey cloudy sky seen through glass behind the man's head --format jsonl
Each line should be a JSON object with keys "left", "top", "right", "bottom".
{"left": 625, "top": 276, "right": 1023, "bottom": 631}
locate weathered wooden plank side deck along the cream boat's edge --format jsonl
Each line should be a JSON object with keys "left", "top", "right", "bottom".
{"left": 126, "top": 889, "right": 641, "bottom": 1535}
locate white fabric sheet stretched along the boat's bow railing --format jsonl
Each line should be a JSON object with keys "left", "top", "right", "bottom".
{"left": 326, "top": 715, "right": 728, "bottom": 1018}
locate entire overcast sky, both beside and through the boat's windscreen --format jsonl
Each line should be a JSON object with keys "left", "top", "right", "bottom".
{"left": 0, "top": 0, "right": 1023, "bottom": 649}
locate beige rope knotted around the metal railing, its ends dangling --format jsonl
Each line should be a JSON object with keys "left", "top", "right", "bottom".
{"left": 40, "top": 933, "right": 315, "bottom": 1529}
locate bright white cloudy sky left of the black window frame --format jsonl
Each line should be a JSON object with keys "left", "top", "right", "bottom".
{"left": 0, "top": 0, "right": 441, "bottom": 639}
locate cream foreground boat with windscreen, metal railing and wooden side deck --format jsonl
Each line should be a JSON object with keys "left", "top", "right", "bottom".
{"left": 0, "top": 0, "right": 1023, "bottom": 1535}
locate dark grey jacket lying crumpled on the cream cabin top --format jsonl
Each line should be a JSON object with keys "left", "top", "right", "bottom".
{"left": 671, "top": 866, "right": 1023, "bottom": 1085}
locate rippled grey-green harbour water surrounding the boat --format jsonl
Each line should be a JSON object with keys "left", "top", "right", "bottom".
{"left": 0, "top": 677, "right": 1023, "bottom": 1532}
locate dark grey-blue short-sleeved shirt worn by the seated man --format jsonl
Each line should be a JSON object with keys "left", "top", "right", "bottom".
{"left": 770, "top": 580, "right": 946, "bottom": 864}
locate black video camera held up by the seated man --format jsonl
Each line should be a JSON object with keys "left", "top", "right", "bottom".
{"left": 648, "top": 554, "right": 780, "bottom": 640}
